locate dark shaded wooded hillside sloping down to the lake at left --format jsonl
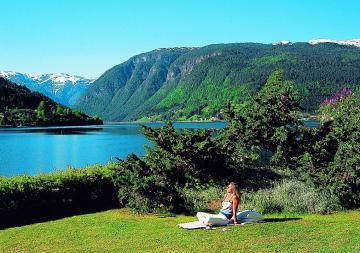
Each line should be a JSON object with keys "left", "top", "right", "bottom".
{"left": 0, "top": 77, "right": 102, "bottom": 127}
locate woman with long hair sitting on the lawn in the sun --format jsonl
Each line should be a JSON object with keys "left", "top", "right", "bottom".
{"left": 196, "top": 182, "right": 240, "bottom": 226}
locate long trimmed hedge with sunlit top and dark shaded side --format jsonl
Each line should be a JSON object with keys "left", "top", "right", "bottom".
{"left": 0, "top": 163, "right": 118, "bottom": 226}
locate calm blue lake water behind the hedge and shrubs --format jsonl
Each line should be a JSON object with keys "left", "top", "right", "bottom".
{"left": 0, "top": 122, "right": 225, "bottom": 176}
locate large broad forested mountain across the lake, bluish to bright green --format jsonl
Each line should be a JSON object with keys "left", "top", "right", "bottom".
{"left": 75, "top": 43, "right": 360, "bottom": 121}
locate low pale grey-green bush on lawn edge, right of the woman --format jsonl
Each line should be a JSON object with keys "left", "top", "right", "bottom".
{"left": 241, "top": 179, "right": 341, "bottom": 214}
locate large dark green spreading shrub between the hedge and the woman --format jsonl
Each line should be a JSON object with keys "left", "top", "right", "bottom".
{"left": 112, "top": 122, "right": 239, "bottom": 212}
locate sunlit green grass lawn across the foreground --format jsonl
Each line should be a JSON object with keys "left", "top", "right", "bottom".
{"left": 0, "top": 209, "right": 360, "bottom": 253}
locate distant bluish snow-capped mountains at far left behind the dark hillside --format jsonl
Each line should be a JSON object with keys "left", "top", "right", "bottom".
{"left": 0, "top": 71, "right": 94, "bottom": 107}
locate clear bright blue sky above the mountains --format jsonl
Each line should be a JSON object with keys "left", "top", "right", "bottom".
{"left": 0, "top": 0, "right": 360, "bottom": 77}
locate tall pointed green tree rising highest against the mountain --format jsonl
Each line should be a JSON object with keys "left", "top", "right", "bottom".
{"left": 222, "top": 70, "right": 304, "bottom": 170}
